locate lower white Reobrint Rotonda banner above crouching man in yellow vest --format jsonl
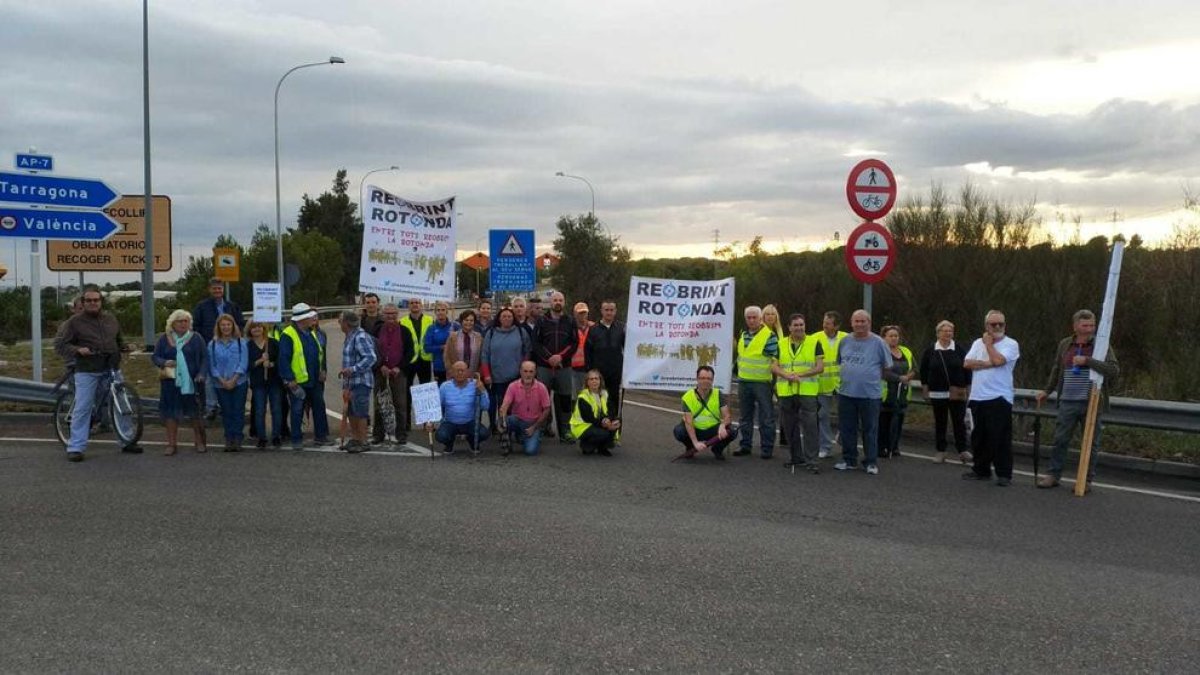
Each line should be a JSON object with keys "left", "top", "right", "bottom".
{"left": 622, "top": 276, "right": 734, "bottom": 392}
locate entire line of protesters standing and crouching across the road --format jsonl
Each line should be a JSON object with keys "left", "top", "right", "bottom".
{"left": 55, "top": 280, "right": 1118, "bottom": 488}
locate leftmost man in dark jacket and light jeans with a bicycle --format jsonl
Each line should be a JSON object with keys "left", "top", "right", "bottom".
{"left": 54, "top": 285, "right": 142, "bottom": 461}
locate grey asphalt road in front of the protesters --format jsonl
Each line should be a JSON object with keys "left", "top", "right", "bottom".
{"left": 0, "top": 374, "right": 1200, "bottom": 673}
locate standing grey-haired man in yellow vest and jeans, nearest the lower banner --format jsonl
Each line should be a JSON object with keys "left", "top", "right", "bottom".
{"left": 733, "top": 305, "right": 779, "bottom": 459}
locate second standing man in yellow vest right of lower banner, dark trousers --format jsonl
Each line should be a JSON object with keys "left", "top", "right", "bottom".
{"left": 770, "top": 313, "right": 824, "bottom": 473}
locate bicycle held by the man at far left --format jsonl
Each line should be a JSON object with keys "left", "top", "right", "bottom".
{"left": 53, "top": 368, "right": 143, "bottom": 448}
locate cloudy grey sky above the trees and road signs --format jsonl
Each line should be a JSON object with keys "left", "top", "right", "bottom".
{"left": 0, "top": 0, "right": 1200, "bottom": 281}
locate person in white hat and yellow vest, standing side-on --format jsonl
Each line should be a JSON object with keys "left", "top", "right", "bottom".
{"left": 280, "top": 303, "right": 334, "bottom": 450}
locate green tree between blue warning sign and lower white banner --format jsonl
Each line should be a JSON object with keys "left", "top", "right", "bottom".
{"left": 553, "top": 214, "right": 630, "bottom": 307}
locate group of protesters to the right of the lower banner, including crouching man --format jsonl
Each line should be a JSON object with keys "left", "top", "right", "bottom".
{"left": 674, "top": 305, "right": 1118, "bottom": 488}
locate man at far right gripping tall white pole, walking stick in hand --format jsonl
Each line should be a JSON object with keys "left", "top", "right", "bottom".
{"left": 1037, "top": 310, "right": 1121, "bottom": 488}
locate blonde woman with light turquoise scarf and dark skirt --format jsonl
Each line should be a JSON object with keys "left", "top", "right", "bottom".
{"left": 150, "top": 310, "right": 209, "bottom": 455}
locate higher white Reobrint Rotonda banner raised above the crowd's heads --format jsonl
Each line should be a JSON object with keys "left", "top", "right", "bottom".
{"left": 359, "top": 185, "right": 456, "bottom": 300}
